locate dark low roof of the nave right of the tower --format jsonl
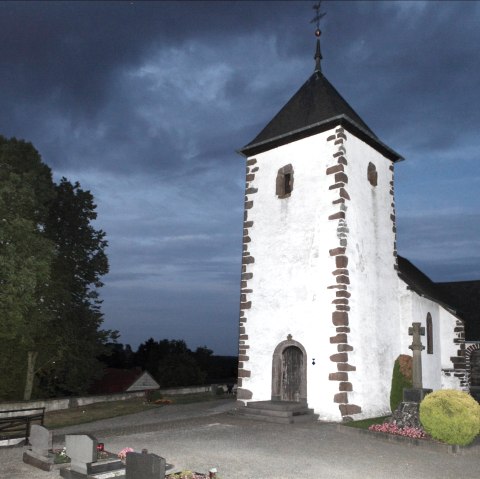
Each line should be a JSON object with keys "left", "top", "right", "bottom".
{"left": 398, "top": 256, "right": 480, "bottom": 341}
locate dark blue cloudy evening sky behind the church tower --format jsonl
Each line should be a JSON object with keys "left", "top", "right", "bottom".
{"left": 0, "top": 1, "right": 480, "bottom": 354}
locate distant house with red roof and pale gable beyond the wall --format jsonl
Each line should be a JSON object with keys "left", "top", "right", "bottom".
{"left": 90, "top": 368, "right": 160, "bottom": 394}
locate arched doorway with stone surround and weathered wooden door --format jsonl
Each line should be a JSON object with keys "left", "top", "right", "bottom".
{"left": 272, "top": 339, "right": 307, "bottom": 403}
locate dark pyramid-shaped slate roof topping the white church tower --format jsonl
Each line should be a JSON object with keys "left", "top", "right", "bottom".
{"left": 240, "top": 71, "right": 402, "bottom": 161}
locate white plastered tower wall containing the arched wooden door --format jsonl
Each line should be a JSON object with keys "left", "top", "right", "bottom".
{"left": 242, "top": 132, "right": 340, "bottom": 419}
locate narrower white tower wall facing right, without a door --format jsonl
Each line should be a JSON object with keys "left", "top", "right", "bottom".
{"left": 345, "top": 134, "right": 400, "bottom": 418}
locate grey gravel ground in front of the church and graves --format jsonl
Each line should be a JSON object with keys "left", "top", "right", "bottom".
{"left": 0, "top": 401, "right": 480, "bottom": 479}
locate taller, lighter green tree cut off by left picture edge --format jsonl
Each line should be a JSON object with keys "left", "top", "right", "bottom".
{"left": 0, "top": 136, "right": 54, "bottom": 397}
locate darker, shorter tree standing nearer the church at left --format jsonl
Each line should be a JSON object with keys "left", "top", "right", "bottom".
{"left": 40, "top": 178, "right": 117, "bottom": 395}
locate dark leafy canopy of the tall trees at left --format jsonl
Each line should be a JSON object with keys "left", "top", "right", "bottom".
{"left": 0, "top": 136, "right": 116, "bottom": 399}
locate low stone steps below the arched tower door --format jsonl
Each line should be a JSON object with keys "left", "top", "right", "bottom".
{"left": 236, "top": 401, "right": 318, "bottom": 424}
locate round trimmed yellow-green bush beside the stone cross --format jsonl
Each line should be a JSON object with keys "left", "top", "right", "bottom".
{"left": 420, "top": 389, "right": 480, "bottom": 446}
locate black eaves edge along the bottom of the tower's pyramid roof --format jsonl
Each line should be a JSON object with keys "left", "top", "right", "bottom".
{"left": 237, "top": 115, "right": 404, "bottom": 163}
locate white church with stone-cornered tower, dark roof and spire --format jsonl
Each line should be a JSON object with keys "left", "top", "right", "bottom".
{"left": 237, "top": 26, "right": 468, "bottom": 421}
